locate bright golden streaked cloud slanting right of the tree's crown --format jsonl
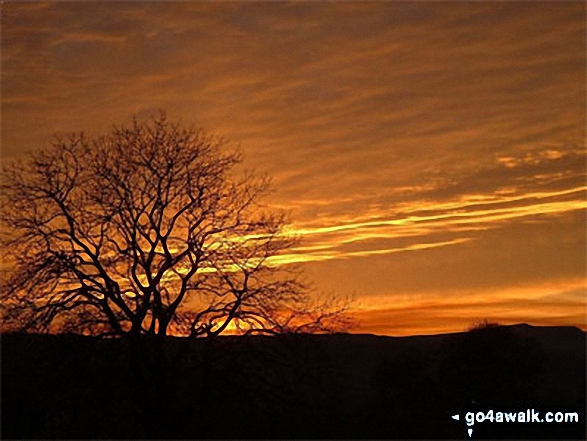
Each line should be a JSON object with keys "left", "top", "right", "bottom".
{"left": 275, "top": 186, "right": 587, "bottom": 262}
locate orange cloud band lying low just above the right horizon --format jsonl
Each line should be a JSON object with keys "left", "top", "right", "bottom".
{"left": 354, "top": 281, "right": 587, "bottom": 335}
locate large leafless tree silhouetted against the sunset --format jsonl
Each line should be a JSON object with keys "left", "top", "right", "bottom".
{"left": 0, "top": 113, "right": 345, "bottom": 337}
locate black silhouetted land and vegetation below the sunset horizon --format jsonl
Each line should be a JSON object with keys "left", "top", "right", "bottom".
{"left": 2, "top": 325, "right": 585, "bottom": 439}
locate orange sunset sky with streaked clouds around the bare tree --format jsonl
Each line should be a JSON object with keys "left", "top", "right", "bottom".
{"left": 1, "top": 1, "right": 587, "bottom": 335}
